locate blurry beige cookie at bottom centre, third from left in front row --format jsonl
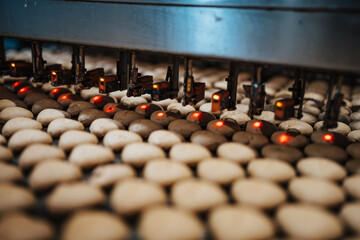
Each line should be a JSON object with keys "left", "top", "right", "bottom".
{"left": 139, "top": 206, "right": 205, "bottom": 240}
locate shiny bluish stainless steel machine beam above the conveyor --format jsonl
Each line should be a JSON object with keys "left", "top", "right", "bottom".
{"left": 0, "top": 0, "right": 360, "bottom": 72}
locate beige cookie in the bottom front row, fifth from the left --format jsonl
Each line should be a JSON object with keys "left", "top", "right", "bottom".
{"left": 276, "top": 204, "right": 343, "bottom": 239}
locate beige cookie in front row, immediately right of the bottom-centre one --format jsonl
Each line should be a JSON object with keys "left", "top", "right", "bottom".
{"left": 209, "top": 205, "right": 275, "bottom": 239}
